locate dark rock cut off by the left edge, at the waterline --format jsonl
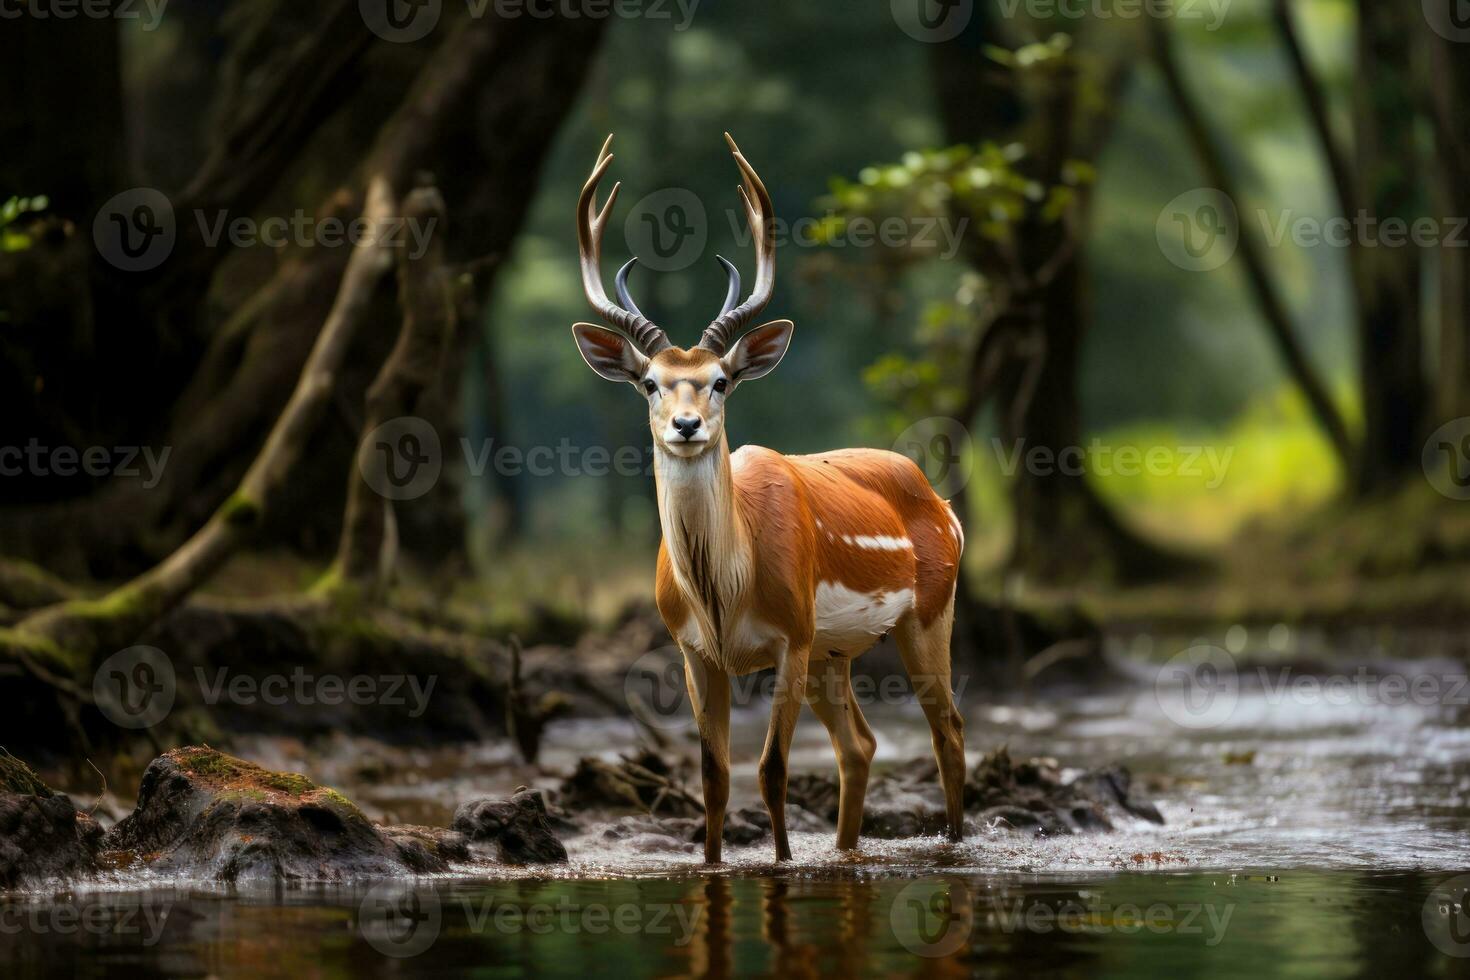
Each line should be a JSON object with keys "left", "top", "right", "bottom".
{"left": 0, "top": 752, "right": 101, "bottom": 889}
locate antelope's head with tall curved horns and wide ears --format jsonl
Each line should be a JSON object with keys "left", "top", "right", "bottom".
{"left": 572, "top": 132, "right": 794, "bottom": 458}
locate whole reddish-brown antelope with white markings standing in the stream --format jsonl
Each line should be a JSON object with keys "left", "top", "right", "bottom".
{"left": 572, "top": 134, "right": 964, "bottom": 864}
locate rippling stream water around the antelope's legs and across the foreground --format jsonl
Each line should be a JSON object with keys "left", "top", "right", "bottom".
{"left": 0, "top": 655, "right": 1470, "bottom": 977}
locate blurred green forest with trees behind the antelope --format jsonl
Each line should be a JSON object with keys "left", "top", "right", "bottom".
{"left": 0, "top": 0, "right": 1470, "bottom": 758}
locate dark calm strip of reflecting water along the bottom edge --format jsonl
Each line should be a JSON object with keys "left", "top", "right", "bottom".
{"left": 0, "top": 870, "right": 1470, "bottom": 979}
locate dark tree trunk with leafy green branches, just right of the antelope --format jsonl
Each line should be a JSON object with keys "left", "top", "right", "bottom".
{"left": 935, "top": 26, "right": 1182, "bottom": 582}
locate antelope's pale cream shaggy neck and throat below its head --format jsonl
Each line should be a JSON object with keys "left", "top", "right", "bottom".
{"left": 654, "top": 433, "right": 751, "bottom": 649}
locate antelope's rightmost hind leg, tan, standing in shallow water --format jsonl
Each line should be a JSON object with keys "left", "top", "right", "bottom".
{"left": 895, "top": 595, "right": 964, "bottom": 840}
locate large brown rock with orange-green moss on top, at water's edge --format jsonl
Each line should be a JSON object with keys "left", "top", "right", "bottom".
{"left": 104, "top": 748, "right": 463, "bottom": 882}
